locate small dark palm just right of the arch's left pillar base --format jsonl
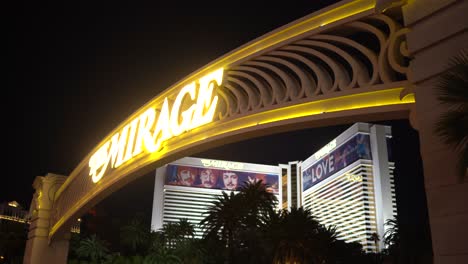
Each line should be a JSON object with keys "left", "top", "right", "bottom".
{"left": 76, "top": 234, "right": 109, "bottom": 263}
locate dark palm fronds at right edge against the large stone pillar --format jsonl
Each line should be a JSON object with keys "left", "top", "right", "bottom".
{"left": 435, "top": 50, "right": 468, "bottom": 180}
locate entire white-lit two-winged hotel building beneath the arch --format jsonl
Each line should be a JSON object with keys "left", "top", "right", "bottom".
{"left": 152, "top": 123, "right": 396, "bottom": 252}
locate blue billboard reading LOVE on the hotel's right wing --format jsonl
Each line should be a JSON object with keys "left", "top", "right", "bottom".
{"left": 302, "top": 134, "right": 372, "bottom": 191}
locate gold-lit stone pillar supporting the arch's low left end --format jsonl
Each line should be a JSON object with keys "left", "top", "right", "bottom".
{"left": 23, "top": 173, "right": 70, "bottom": 264}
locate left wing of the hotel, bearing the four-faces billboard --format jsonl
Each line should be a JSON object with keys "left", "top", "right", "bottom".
{"left": 151, "top": 157, "right": 282, "bottom": 237}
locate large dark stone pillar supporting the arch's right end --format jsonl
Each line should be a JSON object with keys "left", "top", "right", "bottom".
{"left": 403, "top": 0, "right": 468, "bottom": 264}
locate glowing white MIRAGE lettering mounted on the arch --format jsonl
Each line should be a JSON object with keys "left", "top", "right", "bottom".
{"left": 89, "top": 68, "right": 223, "bottom": 183}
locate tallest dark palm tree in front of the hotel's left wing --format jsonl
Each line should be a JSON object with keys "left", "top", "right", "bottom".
{"left": 201, "top": 181, "right": 277, "bottom": 262}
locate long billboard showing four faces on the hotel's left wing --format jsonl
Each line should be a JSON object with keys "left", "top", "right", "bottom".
{"left": 165, "top": 164, "right": 279, "bottom": 194}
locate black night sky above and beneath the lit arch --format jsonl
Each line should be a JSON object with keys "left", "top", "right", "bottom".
{"left": 9, "top": 0, "right": 427, "bottom": 246}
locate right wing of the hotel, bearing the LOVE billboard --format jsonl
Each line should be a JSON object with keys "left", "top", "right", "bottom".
{"left": 298, "top": 123, "right": 396, "bottom": 252}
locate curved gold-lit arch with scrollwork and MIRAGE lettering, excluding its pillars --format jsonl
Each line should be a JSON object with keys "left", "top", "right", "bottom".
{"left": 49, "top": 0, "right": 414, "bottom": 241}
